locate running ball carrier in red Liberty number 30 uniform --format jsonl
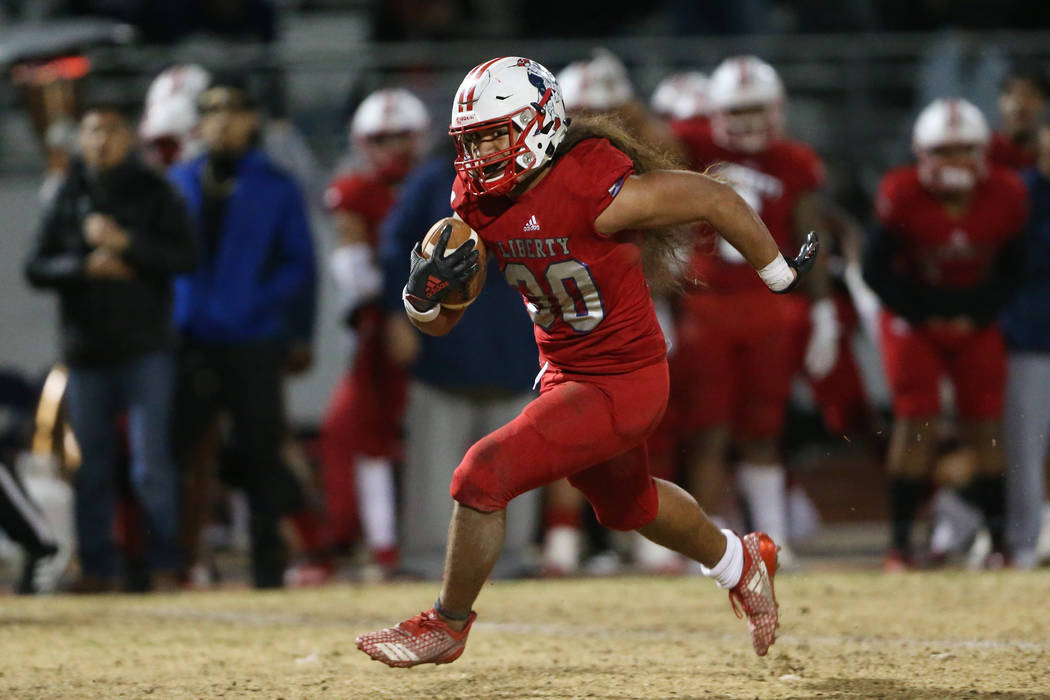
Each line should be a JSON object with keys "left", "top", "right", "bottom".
{"left": 357, "top": 57, "right": 817, "bottom": 666}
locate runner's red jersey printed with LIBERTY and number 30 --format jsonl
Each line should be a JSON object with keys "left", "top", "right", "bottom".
{"left": 453, "top": 139, "right": 667, "bottom": 374}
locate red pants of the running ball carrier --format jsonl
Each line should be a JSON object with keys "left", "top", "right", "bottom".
{"left": 450, "top": 362, "right": 668, "bottom": 530}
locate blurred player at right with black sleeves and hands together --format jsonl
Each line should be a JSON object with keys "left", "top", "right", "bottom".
{"left": 864, "top": 100, "right": 1027, "bottom": 571}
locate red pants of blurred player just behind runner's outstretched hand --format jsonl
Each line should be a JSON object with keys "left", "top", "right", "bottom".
{"left": 671, "top": 290, "right": 806, "bottom": 438}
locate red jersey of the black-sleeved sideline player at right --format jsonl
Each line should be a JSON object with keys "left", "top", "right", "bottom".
{"left": 876, "top": 165, "right": 1028, "bottom": 287}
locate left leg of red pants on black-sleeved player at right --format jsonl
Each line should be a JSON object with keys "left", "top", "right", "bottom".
{"left": 879, "top": 312, "right": 943, "bottom": 418}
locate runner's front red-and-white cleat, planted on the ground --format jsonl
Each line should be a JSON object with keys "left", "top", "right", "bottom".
{"left": 357, "top": 608, "right": 478, "bottom": 669}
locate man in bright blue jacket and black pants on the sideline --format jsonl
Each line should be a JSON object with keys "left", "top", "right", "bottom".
{"left": 170, "top": 81, "right": 316, "bottom": 588}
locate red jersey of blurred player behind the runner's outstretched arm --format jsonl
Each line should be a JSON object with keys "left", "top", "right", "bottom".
{"left": 673, "top": 122, "right": 824, "bottom": 292}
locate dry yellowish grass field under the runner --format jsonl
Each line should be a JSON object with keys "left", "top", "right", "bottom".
{"left": 0, "top": 571, "right": 1050, "bottom": 700}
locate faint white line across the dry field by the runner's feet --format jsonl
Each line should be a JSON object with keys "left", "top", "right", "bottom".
{"left": 137, "top": 608, "right": 1050, "bottom": 652}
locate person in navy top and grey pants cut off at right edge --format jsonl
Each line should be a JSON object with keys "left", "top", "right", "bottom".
{"left": 1000, "top": 122, "right": 1050, "bottom": 569}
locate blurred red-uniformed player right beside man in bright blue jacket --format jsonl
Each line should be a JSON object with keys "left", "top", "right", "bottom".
{"left": 310, "top": 89, "right": 429, "bottom": 571}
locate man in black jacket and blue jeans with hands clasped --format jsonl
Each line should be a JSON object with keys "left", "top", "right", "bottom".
{"left": 25, "top": 101, "right": 194, "bottom": 592}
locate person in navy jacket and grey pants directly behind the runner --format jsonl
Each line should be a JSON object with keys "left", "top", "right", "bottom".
{"left": 379, "top": 153, "right": 539, "bottom": 578}
